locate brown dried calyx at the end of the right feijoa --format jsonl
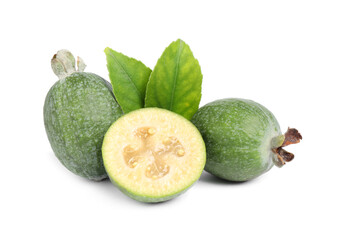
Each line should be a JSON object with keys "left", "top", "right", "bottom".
{"left": 272, "top": 128, "right": 302, "bottom": 167}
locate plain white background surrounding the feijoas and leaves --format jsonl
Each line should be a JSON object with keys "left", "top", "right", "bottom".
{"left": 0, "top": 0, "right": 340, "bottom": 240}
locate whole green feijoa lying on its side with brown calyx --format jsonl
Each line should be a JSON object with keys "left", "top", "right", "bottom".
{"left": 192, "top": 98, "right": 302, "bottom": 181}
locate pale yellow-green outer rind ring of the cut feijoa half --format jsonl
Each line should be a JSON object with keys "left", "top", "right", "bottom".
{"left": 102, "top": 108, "right": 206, "bottom": 202}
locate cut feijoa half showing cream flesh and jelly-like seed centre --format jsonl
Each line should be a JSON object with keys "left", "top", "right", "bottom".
{"left": 102, "top": 108, "right": 206, "bottom": 202}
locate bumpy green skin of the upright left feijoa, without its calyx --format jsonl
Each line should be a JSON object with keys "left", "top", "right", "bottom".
{"left": 44, "top": 72, "right": 123, "bottom": 181}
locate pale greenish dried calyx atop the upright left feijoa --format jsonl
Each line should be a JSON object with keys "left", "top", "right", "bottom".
{"left": 51, "top": 49, "right": 86, "bottom": 79}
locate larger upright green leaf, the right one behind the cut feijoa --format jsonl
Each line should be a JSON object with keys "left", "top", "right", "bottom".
{"left": 145, "top": 39, "right": 203, "bottom": 120}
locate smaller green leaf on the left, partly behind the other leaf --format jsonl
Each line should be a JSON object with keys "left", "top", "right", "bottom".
{"left": 105, "top": 48, "right": 151, "bottom": 113}
